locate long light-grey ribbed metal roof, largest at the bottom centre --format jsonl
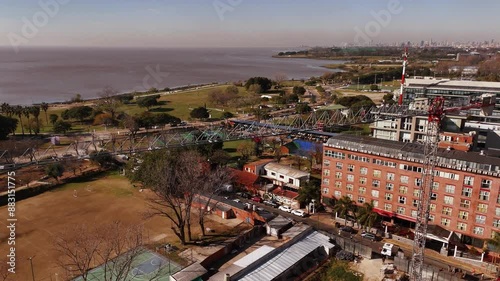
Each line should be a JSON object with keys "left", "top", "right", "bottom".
{"left": 239, "top": 232, "right": 334, "bottom": 281}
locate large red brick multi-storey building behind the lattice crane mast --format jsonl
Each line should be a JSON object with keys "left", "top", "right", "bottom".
{"left": 321, "top": 135, "right": 500, "bottom": 247}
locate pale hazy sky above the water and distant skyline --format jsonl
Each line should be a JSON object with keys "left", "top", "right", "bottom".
{"left": 0, "top": 0, "right": 500, "bottom": 47}
